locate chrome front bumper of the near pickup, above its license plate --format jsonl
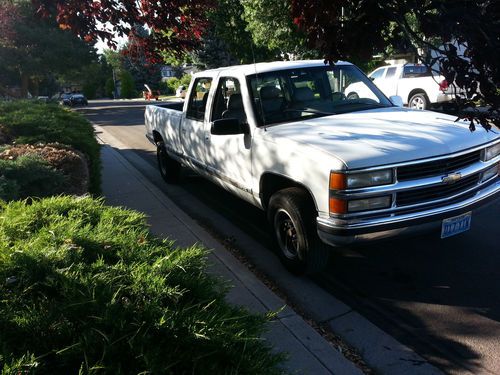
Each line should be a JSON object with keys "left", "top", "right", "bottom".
{"left": 317, "top": 177, "right": 500, "bottom": 246}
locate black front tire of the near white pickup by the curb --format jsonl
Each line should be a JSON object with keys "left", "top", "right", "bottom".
{"left": 267, "top": 188, "right": 330, "bottom": 275}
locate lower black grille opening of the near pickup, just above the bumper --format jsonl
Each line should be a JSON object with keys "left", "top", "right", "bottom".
{"left": 396, "top": 174, "right": 480, "bottom": 207}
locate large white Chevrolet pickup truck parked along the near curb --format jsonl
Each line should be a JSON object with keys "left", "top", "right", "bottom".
{"left": 145, "top": 61, "right": 500, "bottom": 274}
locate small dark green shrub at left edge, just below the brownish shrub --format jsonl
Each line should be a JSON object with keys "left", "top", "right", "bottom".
{"left": 0, "top": 155, "right": 66, "bottom": 201}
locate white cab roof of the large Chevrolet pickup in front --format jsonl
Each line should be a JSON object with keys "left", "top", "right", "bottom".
{"left": 196, "top": 60, "right": 352, "bottom": 76}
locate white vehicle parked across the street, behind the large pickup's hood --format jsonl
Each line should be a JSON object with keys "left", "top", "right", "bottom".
{"left": 345, "top": 64, "right": 458, "bottom": 109}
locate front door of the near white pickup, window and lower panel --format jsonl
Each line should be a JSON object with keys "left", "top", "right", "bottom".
{"left": 207, "top": 77, "right": 252, "bottom": 199}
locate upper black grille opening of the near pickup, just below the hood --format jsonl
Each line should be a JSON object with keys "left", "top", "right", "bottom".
{"left": 398, "top": 150, "right": 481, "bottom": 181}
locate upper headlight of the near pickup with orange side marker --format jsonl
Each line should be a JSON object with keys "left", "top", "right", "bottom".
{"left": 330, "top": 169, "right": 394, "bottom": 190}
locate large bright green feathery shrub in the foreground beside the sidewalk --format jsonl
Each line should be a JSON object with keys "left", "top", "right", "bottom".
{"left": 0, "top": 197, "right": 282, "bottom": 374}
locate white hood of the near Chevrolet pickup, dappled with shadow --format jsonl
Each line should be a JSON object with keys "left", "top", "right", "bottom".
{"left": 266, "top": 107, "right": 499, "bottom": 169}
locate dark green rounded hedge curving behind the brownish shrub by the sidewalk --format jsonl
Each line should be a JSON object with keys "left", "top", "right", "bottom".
{"left": 0, "top": 101, "right": 101, "bottom": 194}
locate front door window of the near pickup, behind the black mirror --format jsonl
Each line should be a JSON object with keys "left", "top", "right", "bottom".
{"left": 212, "top": 77, "right": 246, "bottom": 123}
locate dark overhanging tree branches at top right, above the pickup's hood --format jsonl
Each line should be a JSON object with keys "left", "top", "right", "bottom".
{"left": 291, "top": 0, "right": 500, "bottom": 130}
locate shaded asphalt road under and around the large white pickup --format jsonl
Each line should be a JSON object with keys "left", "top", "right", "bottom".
{"left": 84, "top": 101, "right": 500, "bottom": 374}
